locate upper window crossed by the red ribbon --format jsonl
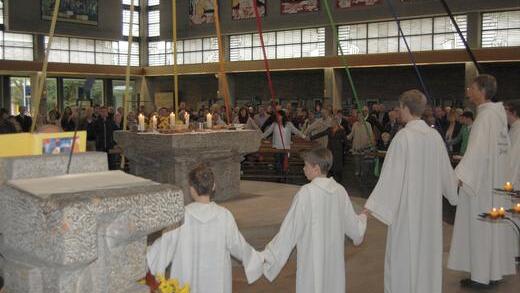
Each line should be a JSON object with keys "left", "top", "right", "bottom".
{"left": 229, "top": 28, "right": 325, "bottom": 61}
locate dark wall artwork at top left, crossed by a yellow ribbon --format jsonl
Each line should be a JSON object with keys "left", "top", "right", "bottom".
{"left": 41, "top": 0, "right": 98, "bottom": 25}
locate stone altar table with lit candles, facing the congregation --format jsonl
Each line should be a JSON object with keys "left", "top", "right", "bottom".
{"left": 114, "top": 130, "right": 261, "bottom": 202}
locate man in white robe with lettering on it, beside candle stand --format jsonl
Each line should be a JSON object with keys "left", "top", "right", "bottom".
{"left": 448, "top": 75, "right": 515, "bottom": 288}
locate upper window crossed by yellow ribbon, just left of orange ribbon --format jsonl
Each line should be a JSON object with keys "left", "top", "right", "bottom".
{"left": 148, "top": 38, "right": 218, "bottom": 66}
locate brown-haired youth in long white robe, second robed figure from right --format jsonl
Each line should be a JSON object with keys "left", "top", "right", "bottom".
{"left": 365, "top": 90, "right": 457, "bottom": 293}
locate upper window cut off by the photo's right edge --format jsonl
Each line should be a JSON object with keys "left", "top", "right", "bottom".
{"left": 482, "top": 10, "right": 520, "bottom": 48}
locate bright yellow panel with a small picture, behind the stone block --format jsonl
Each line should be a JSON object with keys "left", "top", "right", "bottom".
{"left": 0, "top": 131, "right": 87, "bottom": 157}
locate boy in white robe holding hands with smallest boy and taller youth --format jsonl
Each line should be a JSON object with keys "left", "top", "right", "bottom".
{"left": 263, "top": 147, "right": 367, "bottom": 293}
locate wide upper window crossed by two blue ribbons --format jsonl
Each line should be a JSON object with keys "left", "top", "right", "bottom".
{"left": 338, "top": 15, "right": 467, "bottom": 55}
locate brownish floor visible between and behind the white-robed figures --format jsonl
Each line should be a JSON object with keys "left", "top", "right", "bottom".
{"left": 228, "top": 181, "right": 520, "bottom": 293}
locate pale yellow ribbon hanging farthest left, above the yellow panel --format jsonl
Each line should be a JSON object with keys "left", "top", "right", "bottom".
{"left": 31, "top": 0, "right": 61, "bottom": 132}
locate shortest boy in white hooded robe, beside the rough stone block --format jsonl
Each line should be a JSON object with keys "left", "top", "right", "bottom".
{"left": 147, "top": 165, "right": 263, "bottom": 293}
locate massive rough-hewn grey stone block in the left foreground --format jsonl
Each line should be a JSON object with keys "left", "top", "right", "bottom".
{"left": 0, "top": 153, "right": 184, "bottom": 293}
